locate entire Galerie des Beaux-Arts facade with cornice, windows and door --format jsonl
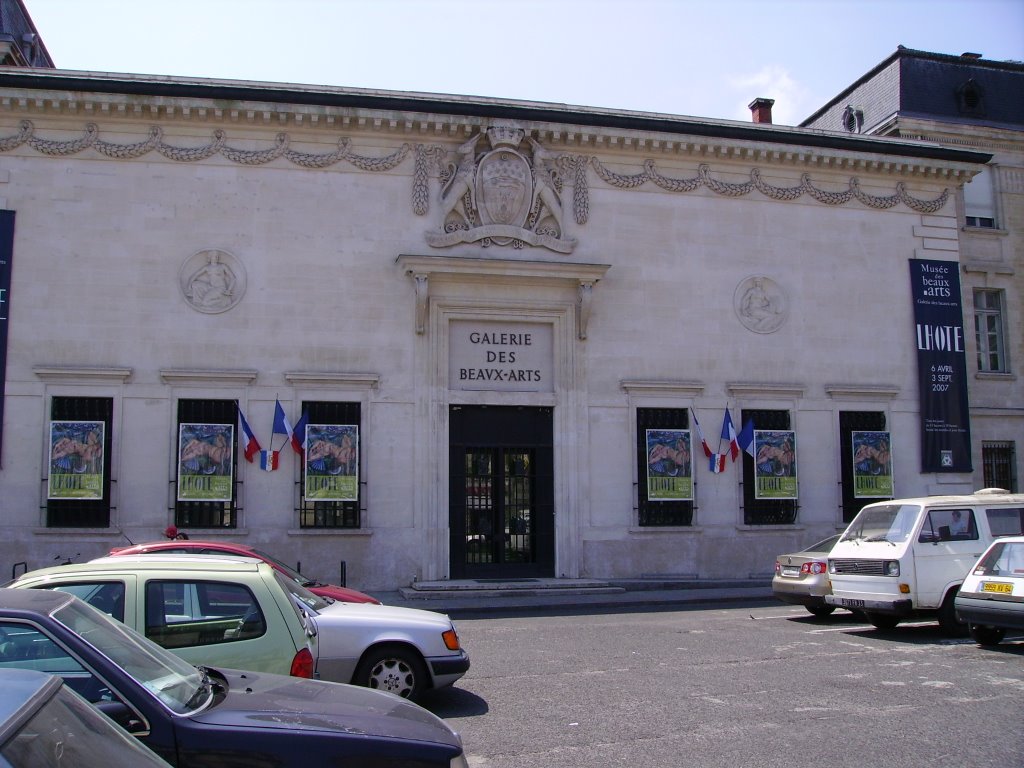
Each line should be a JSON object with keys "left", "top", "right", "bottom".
{"left": 0, "top": 61, "right": 990, "bottom": 591}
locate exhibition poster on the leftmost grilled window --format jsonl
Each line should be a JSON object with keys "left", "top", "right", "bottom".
{"left": 47, "top": 421, "right": 106, "bottom": 499}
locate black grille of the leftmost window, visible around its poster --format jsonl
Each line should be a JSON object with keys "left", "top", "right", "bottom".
{"left": 46, "top": 397, "right": 114, "bottom": 528}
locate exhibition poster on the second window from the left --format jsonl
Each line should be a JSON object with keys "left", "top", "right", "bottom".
{"left": 178, "top": 424, "right": 234, "bottom": 502}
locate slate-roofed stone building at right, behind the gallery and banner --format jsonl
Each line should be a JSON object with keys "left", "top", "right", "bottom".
{"left": 802, "top": 47, "right": 1024, "bottom": 490}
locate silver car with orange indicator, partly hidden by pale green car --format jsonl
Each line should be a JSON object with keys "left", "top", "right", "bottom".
{"left": 288, "top": 584, "right": 469, "bottom": 699}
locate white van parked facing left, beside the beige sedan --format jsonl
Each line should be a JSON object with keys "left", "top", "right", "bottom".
{"left": 825, "top": 488, "right": 1024, "bottom": 635}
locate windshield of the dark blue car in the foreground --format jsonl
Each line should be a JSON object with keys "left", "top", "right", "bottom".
{"left": 53, "top": 600, "right": 212, "bottom": 715}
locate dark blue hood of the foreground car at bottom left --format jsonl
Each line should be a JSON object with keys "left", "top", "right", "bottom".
{"left": 190, "top": 669, "right": 462, "bottom": 750}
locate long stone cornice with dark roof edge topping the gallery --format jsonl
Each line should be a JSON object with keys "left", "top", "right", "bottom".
{"left": 0, "top": 71, "right": 987, "bottom": 177}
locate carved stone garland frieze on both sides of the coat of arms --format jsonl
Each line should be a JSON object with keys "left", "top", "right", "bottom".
{"left": 0, "top": 120, "right": 949, "bottom": 219}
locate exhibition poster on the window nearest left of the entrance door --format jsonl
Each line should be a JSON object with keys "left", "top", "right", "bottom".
{"left": 305, "top": 424, "right": 359, "bottom": 502}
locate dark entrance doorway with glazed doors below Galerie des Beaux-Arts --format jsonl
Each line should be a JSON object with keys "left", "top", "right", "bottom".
{"left": 449, "top": 406, "right": 555, "bottom": 580}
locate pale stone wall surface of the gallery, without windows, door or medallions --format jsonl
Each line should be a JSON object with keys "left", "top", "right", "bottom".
{"left": 0, "top": 87, "right": 970, "bottom": 591}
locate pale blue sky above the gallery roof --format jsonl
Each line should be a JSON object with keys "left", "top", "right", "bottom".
{"left": 24, "top": 0, "right": 1024, "bottom": 125}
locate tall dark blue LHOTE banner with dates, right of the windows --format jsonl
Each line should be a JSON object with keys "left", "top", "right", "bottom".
{"left": 910, "top": 259, "right": 973, "bottom": 472}
